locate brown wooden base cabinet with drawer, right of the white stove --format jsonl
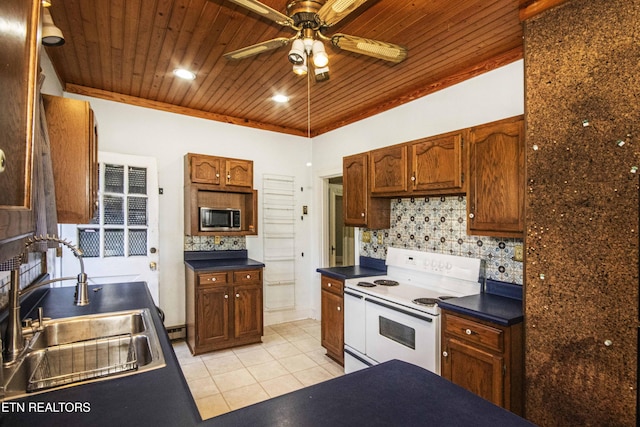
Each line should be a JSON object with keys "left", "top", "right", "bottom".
{"left": 441, "top": 310, "right": 523, "bottom": 415}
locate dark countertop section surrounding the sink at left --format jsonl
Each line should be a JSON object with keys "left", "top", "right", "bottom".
{"left": 0, "top": 282, "right": 201, "bottom": 427}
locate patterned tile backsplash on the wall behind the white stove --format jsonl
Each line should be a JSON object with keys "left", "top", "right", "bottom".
{"left": 360, "top": 196, "right": 523, "bottom": 285}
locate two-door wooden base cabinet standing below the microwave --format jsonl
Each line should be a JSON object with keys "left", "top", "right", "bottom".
{"left": 186, "top": 268, "right": 263, "bottom": 355}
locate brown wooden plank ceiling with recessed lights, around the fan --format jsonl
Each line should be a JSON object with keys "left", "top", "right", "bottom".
{"left": 42, "top": 0, "right": 531, "bottom": 136}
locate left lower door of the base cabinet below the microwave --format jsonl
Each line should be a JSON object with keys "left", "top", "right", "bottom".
{"left": 196, "top": 286, "right": 230, "bottom": 347}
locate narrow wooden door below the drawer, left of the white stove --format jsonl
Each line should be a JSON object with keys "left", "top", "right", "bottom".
{"left": 320, "top": 290, "right": 344, "bottom": 363}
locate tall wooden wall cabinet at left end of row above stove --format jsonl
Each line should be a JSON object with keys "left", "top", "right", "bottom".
{"left": 342, "top": 153, "right": 391, "bottom": 229}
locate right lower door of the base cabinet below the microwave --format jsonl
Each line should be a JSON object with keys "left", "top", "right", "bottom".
{"left": 233, "top": 285, "right": 262, "bottom": 339}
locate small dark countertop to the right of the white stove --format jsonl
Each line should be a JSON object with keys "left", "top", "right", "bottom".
{"left": 438, "top": 280, "right": 524, "bottom": 326}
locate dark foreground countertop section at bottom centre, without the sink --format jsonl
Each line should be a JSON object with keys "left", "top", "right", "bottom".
{"left": 203, "top": 360, "right": 534, "bottom": 427}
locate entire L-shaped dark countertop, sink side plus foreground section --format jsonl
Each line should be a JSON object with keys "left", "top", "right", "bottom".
{"left": 0, "top": 282, "right": 532, "bottom": 427}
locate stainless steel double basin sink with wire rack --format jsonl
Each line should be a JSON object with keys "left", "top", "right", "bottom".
{"left": 3, "top": 308, "right": 165, "bottom": 400}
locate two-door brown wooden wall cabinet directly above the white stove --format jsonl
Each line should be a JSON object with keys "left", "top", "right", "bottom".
{"left": 370, "top": 131, "right": 465, "bottom": 197}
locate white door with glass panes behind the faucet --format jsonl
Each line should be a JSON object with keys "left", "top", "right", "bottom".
{"left": 60, "top": 152, "right": 159, "bottom": 305}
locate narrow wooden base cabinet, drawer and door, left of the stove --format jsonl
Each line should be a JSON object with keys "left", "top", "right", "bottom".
{"left": 320, "top": 276, "right": 344, "bottom": 365}
